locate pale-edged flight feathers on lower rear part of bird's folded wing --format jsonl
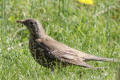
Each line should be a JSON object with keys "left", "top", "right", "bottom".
{"left": 51, "top": 48, "right": 91, "bottom": 68}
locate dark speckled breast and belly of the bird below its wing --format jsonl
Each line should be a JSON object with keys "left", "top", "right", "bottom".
{"left": 29, "top": 37, "right": 66, "bottom": 68}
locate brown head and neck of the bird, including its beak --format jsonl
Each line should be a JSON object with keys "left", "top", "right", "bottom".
{"left": 17, "top": 19, "right": 45, "bottom": 35}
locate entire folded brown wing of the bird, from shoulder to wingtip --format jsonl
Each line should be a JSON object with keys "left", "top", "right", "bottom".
{"left": 37, "top": 38, "right": 94, "bottom": 68}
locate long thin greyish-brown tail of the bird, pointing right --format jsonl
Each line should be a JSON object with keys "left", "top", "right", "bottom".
{"left": 85, "top": 56, "right": 118, "bottom": 62}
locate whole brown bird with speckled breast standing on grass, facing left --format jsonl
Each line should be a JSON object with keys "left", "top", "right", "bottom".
{"left": 17, "top": 18, "right": 115, "bottom": 69}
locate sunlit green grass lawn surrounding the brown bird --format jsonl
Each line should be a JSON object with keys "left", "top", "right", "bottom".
{"left": 0, "top": 0, "right": 120, "bottom": 80}
